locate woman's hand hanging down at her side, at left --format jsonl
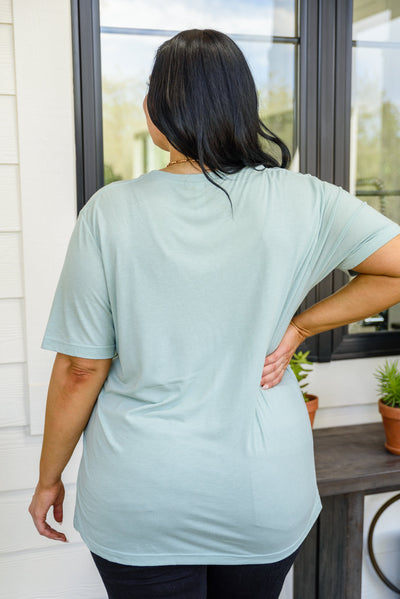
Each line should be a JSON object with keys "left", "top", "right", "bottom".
{"left": 29, "top": 480, "right": 67, "bottom": 543}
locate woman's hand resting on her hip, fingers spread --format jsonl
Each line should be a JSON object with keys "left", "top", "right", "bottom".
{"left": 261, "top": 322, "right": 308, "bottom": 389}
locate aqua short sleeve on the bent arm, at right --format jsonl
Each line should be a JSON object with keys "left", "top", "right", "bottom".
{"left": 315, "top": 182, "right": 400, "bottom": 280}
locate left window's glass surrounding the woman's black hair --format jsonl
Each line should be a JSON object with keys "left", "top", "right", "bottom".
{"left": 100, "top": 0, "right": 298, "bottom": 183}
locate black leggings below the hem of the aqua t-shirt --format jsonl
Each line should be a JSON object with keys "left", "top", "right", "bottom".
{"left": 92, "top": 547, "right": 300, "bottom": 599}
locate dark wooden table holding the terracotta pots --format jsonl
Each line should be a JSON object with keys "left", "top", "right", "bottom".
{"left": 293, "top": 422, "right": 400, "bottom": 599}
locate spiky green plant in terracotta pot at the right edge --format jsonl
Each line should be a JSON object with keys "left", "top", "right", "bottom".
{"left": 374, "top": 360, "right": 400, "bottom": 455}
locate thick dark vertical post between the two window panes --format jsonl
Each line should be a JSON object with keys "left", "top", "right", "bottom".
{"left": 299, "top": 0, "right": 352, "bottom": 362}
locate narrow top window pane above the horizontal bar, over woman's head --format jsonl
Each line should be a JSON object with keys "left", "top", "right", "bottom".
{"left": 100, "top": 0, "right": 296, "bottom": 37}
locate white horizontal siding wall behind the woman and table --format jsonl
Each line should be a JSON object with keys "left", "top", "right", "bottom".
{"left": 0, "top": 0, "right": 399, "bottom": 599}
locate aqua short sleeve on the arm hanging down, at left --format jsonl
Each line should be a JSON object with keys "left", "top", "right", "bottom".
{"left": 41, "top": 210, "right": 115, "bottom": 359}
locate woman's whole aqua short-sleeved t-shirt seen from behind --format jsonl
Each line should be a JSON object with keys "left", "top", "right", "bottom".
{"left": 42, "top": 168, "right": 400, "bottom": 565}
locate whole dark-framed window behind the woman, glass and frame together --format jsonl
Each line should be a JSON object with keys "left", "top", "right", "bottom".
{"left": 71, "top": 0, "right": 400, "bottom": 361}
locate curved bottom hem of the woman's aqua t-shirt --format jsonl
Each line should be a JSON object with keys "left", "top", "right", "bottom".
{"left": 74, "top": 494, "right": 322, "bottom": 566}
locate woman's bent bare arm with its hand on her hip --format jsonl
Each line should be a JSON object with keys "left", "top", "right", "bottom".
{"left": 261, "top": 235, "right": 400, "bottom": 388}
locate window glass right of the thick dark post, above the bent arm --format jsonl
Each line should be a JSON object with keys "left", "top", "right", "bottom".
{"left": 349, "top": 0, "right": 400, "bottom": 333}
